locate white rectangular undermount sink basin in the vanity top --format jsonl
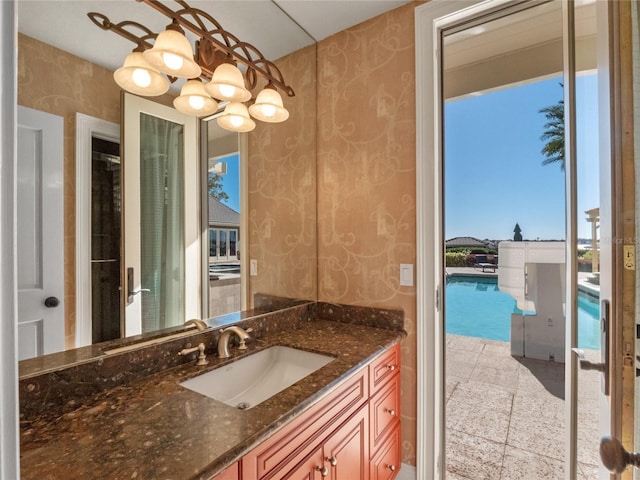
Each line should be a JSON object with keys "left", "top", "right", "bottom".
{"left": 180, "top": 346, "right": 334, "bottom": 410}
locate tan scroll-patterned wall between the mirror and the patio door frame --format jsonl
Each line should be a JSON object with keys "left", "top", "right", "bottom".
{"left": 318, "top": 4, "right": 416, "bottom": 464}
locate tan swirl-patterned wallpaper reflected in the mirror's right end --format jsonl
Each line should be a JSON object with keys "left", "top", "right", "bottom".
{"left": 249, "top": 45, "right": 317, "bottom": 300}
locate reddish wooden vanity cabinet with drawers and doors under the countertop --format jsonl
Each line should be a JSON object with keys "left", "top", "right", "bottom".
{"left": 230, "top": 345, "right": 400, "bottom": 480}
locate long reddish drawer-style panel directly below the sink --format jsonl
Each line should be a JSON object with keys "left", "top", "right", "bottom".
{"left": 242, "top": 368, "right": 369, "bottom": 480}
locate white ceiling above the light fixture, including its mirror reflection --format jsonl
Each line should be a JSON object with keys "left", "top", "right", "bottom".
{"left": 17, "top": 0, "right": 408, "bottom": 74}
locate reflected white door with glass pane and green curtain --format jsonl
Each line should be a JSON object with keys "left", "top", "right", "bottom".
{"left": 122, "top": 94, "right": 202, "bottom": 336}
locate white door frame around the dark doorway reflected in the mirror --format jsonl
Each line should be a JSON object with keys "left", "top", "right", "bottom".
{"left": 75, "top": 113, "right": 120, "bottom": 348}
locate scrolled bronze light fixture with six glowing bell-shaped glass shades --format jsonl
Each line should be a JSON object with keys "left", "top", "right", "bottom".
{"left": 87, "top": 0, "right": 295, "bottom": 132}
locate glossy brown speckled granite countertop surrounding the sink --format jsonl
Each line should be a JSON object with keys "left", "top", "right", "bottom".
{"left": 20, "top": 320, "right": 404, "bottom": 480}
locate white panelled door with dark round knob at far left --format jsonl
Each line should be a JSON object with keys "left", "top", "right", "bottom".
{"left": 17, "top": 106, "right": 65, "bottom": 360}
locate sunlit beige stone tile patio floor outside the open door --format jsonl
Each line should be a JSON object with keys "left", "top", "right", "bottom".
{"left": 446, "top": 335, "right": 600, "bottom": 480}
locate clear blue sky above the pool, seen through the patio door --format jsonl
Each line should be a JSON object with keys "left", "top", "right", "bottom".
{"left": 445, "top": 75, "right": 598, "bottom": 240}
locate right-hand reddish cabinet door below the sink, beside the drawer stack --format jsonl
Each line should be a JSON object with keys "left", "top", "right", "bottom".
{"left": 324, "top": 408, "right": 369, "bottom": 480}
